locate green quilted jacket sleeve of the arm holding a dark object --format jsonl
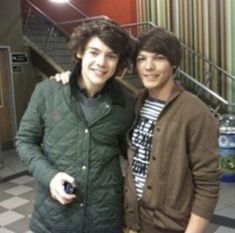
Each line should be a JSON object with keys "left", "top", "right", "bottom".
{"left": 16, "top": 84, "right": 58, "bottom": 186}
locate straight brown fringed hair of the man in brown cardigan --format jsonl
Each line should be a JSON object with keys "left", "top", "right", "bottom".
{"left": 134, "top": 27, "right": 181, "bottom": 68}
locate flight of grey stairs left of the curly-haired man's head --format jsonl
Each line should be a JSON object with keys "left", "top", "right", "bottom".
{"left": 23, "top": 1, "right": 72, "bottom": 72}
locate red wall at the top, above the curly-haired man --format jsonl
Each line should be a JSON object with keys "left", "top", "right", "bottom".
{"left": 21, "top": 0, "right": 136, "bottom": 24}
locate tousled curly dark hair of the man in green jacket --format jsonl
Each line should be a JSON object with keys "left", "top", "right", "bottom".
{"left": 69, "top": 19, "right": 132, "bottom": 72}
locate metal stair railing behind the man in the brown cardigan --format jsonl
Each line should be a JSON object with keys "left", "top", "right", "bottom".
{"left": 123, "top": 22, "right": 235, "bottom": 115}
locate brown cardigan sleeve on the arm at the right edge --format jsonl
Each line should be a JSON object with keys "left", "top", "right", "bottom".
{"left": 188, "top": 108, "right": 221, "bottom": 219}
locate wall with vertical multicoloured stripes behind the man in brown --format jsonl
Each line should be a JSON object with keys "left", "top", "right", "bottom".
{"left": 137, "top": 0, "right": 235, "bottom": 106}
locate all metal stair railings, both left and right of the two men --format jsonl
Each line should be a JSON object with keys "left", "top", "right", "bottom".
{"left": 24, "top": 0, "right": 235, "bottom": 115}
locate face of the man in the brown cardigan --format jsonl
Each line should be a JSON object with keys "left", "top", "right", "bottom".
{"left": 136, "top": 50, "right": 174, "bottom": 100}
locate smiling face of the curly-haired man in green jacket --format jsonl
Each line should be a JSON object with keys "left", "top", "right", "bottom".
{"left": 78, "top": 37, "right": 119, "bottom": 89}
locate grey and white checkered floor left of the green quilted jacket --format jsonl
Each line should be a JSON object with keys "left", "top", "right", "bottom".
{"left": 0, "top": 176, "right": 34, "bottom": 233}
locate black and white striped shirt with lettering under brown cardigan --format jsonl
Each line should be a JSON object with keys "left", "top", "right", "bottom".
{"left": 131, "top": 97, "right": 165, "bottom": 199}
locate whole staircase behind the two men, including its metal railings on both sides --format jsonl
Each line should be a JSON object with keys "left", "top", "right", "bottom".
{"left": 21, "top": 0, "right": 235, "bottom": 117}
